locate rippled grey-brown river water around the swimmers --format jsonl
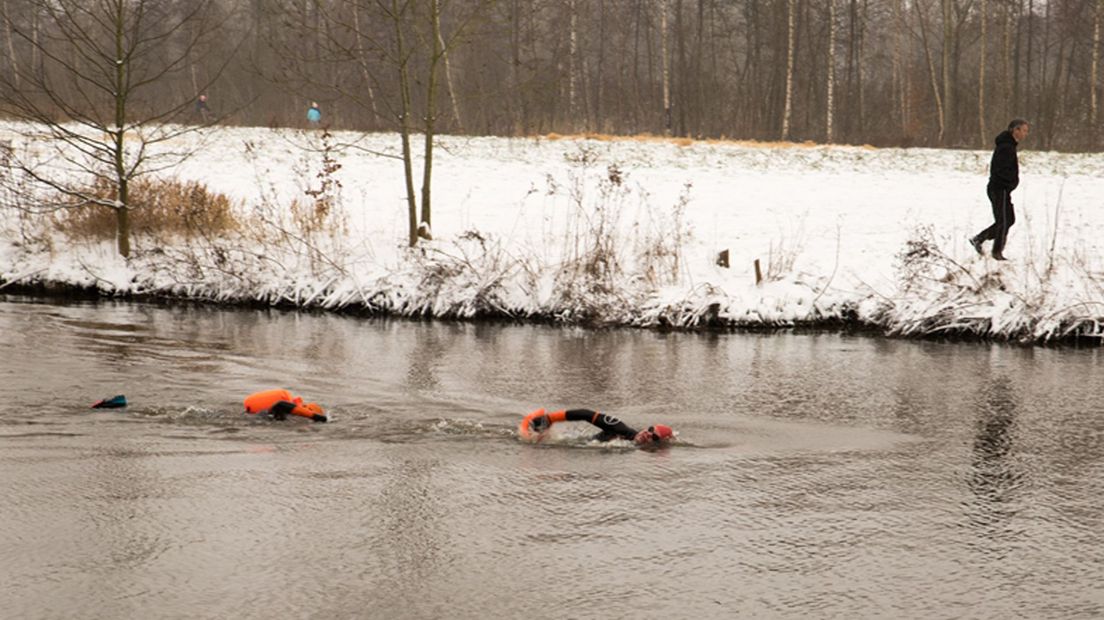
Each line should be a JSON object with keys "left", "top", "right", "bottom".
{"left": 0, "top": 297, "right": 1104, "bottom": 619}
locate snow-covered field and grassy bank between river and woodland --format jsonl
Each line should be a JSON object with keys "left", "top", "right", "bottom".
{"left": 0, "top": 120, "right": 1104, "bottom": 341}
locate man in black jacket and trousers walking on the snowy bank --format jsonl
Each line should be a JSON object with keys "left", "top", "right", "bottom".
{"left": 969, "top": 118, "right": 1030, "bottom": 260}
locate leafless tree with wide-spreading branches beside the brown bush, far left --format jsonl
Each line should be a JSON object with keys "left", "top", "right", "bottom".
{"left": 0, "top": 0, "right": 240, "bottom": 257}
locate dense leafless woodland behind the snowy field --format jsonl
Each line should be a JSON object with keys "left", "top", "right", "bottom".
{"left": 0, "top": 0, "right": 1104, "bottom": 150}
